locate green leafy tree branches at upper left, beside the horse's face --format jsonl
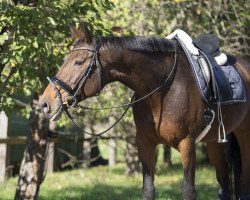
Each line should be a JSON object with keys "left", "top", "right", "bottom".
{"left": 0, "top": 0, "right": 112, "bottom": 115}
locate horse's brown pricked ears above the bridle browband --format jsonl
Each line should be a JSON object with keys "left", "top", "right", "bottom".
{"left": 69, "top": 23, "right": 92, "bottom": 43}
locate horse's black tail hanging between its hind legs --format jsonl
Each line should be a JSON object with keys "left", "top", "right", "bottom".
{"left": 226, "top": 133, "right": 242, "bottom": 199}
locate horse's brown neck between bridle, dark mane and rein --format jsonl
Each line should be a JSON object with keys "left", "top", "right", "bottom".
{"left": 103, "top": 48, "right": 174, "bottom": 94}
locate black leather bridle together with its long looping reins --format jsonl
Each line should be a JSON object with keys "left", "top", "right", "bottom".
{"left": 47, "top": 40, "right": 177, "bottom": 137}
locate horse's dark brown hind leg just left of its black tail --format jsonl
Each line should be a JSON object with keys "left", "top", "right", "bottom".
{"left": 207, "top": 141, "right": 229, "bottom": 200}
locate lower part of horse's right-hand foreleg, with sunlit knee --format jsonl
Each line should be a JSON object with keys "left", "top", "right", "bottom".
{"left": 179, "top": 137, "right": 196, "bottom": 200}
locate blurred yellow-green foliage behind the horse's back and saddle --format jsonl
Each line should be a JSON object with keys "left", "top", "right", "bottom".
{"left": 106, "top": 0, "right": 250, "bottom": 58}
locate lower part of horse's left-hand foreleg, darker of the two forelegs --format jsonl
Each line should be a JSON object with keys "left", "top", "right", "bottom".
{"left": 137, "top": 134, "right": 156, "bottom": 200}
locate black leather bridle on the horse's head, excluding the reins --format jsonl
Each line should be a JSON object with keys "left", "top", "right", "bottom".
{"left": 47, "top": 40, "right": 102, "bottom": 107}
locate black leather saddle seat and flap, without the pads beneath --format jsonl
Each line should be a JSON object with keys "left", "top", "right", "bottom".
{"left": 193, "top": 34, "right": 233, "bottom": 102}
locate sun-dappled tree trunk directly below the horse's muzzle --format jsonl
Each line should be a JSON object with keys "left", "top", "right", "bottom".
{"left": 15, "top": 94, "right": 49, "bottom": 199}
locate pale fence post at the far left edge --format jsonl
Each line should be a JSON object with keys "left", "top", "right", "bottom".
{"left": 0, "top": 111, "right": 8, "bottom": 182}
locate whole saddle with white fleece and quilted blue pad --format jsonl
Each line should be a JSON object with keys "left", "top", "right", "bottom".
{"left": 167, "top": 30, "right": 246, "bottom": 104}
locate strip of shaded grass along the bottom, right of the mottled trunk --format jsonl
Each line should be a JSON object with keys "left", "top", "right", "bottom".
{"left": 39, "top": 181, "right": 216, "bottom": 200}
